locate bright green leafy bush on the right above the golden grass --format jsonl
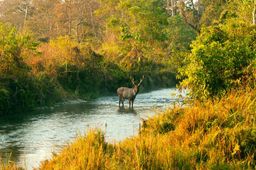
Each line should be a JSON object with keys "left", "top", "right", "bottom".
{"left": 180, "top": 20, "right": 256, "bottom": 99}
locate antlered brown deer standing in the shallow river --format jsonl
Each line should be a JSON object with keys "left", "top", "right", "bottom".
{"left": 117, "top": 75, "right": 145, "bottom": 109}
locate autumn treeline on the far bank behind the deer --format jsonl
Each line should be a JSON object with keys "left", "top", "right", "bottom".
{"left": 0, "top": 0, "right": 196, "bottom": 113}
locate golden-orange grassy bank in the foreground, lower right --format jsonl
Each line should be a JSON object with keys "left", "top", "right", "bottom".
{"left": 40, "top": 89, "right": 256, "bottom": 170}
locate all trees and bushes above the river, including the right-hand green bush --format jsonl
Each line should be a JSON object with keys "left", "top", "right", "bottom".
{"left": 0, "top": 0, "right": 255, "bottom": 113}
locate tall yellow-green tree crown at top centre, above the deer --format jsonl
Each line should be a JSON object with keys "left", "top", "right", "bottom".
{"left": 98, "top": 0, "right": 168, "bottom": 53}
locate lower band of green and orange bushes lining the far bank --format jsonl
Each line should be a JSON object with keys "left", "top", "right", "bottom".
{"left": 0, "top": 24, "right": 175, "bottom": 113}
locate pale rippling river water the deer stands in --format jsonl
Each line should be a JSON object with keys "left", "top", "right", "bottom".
{"left": 0, "top": 88, "right": 184, "bottom": 170}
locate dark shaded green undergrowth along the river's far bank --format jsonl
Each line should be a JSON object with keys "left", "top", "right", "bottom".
{"left": 0, "top": 69, "right": 177, "bottom": 115}
